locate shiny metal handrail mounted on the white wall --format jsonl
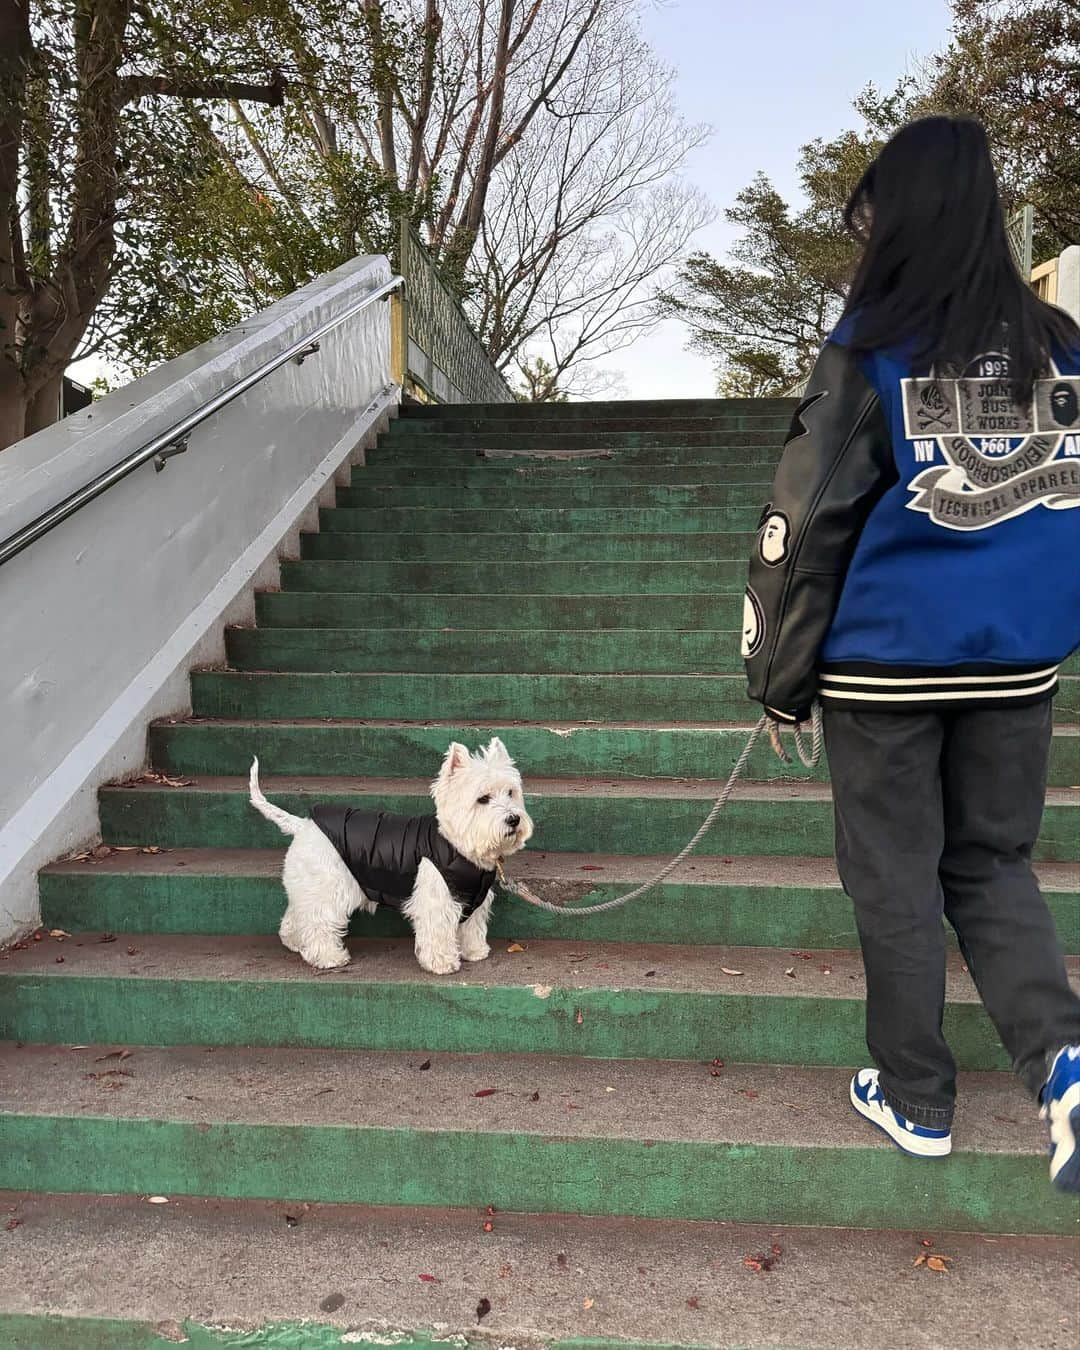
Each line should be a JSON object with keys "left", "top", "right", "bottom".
{"left": 0, "top": 277, "right": 405, "bottom": 566}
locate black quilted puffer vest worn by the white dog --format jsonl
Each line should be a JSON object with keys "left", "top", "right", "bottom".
{"left": 312, "top": 805, "right": 495, "bottom": 921}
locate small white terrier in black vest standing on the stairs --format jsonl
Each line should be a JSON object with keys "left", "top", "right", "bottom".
{"left": 251, "top": 737, "right": 532, "bottom": 975}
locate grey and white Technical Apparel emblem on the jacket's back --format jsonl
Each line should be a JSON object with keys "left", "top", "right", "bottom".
{"left": 900, "top": 352, "right": 1080, "bottom": 531}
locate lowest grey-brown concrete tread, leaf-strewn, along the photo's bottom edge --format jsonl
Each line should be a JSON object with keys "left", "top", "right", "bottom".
{"left": 0, "top": 1192, "right": 1080, "bottom": 1350}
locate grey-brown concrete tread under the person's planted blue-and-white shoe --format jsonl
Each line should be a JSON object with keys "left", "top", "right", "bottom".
{"left": 0, "top": 1036, "right": 1053, "bottom": 1155}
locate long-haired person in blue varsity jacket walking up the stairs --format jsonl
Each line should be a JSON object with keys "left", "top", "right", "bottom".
{"left": 743, "top": 116, "right": 1080, "bottom": 1191}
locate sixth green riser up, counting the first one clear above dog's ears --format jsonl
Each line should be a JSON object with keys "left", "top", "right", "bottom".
{"left": 315, "top": 507, "right": 761, "bottom": 535}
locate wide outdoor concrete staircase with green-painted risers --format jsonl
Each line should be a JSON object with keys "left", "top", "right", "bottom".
{"left": 0, "top": 401, "right": 1080, "bottom": 1350}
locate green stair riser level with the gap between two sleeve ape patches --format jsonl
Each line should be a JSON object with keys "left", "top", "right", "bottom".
{"left": 281, "top": 559, "right": 745, "bottom": 596}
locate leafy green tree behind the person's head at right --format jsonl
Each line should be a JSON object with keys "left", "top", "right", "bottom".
{"left": 662, "top": 0, "right": 1080, "bottom": 396}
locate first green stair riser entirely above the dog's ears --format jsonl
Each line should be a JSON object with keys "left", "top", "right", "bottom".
{"left": 192, "top": 671, "right": 1080, "bottom": 723}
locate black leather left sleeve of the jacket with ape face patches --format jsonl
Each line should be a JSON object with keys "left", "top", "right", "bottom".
{"left": 743, "top": 343, "right": 898, "bottom": 722}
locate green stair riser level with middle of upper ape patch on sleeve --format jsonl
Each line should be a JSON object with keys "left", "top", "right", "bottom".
{"left": 300, "top": 526, "right": 755, "bottom": 563}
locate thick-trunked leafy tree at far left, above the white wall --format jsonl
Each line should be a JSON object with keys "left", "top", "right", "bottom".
{"left": 0, "top": 0, "right": 285, "bottom": 448}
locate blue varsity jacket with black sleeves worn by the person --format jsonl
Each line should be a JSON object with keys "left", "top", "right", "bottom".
{"left": 743, "top": 329, "right": 1080, "bottom": 722}
